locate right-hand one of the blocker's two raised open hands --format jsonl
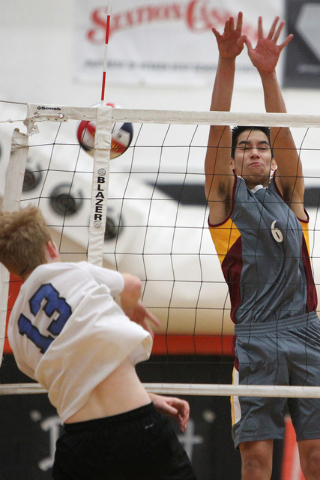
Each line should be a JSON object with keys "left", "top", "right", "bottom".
{"left": 245, "top": 17, "right": 293, "bottom": 73}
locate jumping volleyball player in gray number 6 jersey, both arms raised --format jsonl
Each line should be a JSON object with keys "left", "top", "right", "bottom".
{"left": 205, "top": 12, "right": 320, "bottom": 480}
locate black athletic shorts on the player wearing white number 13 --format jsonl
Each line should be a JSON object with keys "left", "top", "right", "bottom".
{"left": 52, "top": 403, "right": 196, "bottom": 480}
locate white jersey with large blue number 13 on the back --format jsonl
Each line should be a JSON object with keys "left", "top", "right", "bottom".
{"left": 8, "top": 262, "right": 152, "bottom": 422}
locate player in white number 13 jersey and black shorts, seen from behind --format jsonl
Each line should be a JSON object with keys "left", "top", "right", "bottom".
{"left": 0, "top": 206, "right": 196, "bottom": 480}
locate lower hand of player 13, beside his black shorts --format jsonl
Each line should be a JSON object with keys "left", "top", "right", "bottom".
{"left": 148, "top": 393, "right": 190, "bottom": 432}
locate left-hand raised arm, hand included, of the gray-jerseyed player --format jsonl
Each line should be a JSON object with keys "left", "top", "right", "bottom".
{"left": 205, "top": 12, "right": 246, "bottom": 224}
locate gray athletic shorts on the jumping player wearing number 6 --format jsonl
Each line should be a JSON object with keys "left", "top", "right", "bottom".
{"left": 231, "top": 312, "right": 320, "bottom": 448}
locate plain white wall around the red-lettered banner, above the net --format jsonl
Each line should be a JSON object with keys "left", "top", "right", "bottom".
{"left": 0, "top": 0, "right": 320, "bottom": 114}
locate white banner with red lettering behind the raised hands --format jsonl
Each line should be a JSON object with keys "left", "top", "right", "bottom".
{"left": 76, "top": 0, "right": 284, "bottom": 87}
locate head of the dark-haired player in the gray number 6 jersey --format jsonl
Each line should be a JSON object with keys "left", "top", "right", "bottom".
{"left": 231, "top": 129, "right": 276, "bottom": 188}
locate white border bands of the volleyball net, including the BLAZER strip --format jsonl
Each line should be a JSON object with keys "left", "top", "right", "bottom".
{"left": 0, "top": 108, "right": 320, "bottom": 398}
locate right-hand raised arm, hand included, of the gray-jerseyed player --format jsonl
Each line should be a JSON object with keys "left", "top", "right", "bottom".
{"left": 246, "top": 17, "right": 306, "bottom": 219}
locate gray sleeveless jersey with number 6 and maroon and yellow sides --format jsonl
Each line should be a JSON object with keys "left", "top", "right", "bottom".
{"left": 209, "top": 177, "right": 317, "bottom": 324}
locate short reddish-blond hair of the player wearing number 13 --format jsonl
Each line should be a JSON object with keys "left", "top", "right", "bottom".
{"left": 0, "top": 205, "right": 51, "bottom": 278}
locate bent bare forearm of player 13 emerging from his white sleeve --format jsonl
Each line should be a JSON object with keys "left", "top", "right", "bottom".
{"left": 120, "top": 273, "right": 160, "bottom": 337}
